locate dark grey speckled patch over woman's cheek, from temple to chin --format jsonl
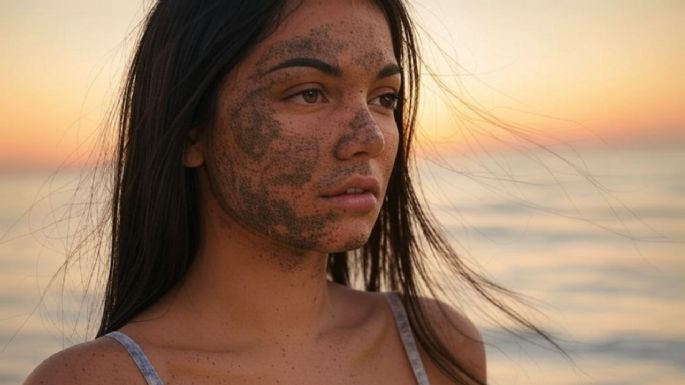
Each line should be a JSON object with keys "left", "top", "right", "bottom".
{"left": 208, "top": 74, "right": 336, "bottom": 270}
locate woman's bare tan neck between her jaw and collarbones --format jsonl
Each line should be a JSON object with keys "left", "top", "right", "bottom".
{"left": 161, "top": 207, "right": 335, "bottom": 343}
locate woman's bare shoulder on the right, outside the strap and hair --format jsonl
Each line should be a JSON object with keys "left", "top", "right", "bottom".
{"left": 412, "top": 298, "right": 487, "bottom": 385}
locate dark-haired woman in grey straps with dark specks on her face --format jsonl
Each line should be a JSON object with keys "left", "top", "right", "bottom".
{"left": 26, "top": 0, "right": 530, "bottom": 385}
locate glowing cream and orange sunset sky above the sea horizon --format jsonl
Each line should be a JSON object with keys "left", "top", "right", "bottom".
{"left": 0, "top": 0, "right": 685, "bottom": 170}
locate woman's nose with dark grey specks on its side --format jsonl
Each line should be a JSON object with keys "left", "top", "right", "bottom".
{"left": 334, "top": 106, "right": 385, "bottom": 159}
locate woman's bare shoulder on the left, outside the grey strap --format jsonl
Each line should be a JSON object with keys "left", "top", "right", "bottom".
{"left": 24, "top": 337, "right": 145, "bottom": 385}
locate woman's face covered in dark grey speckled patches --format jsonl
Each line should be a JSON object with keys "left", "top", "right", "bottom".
{"left": 196, "top": 0, "right": 401, "bottom": 252}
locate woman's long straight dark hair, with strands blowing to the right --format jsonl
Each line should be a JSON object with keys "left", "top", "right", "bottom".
{"left": 97, "top": 0, "right": 560, "bottom": 383}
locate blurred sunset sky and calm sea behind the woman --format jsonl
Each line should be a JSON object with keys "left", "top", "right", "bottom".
{"left": 0, "top": 0, "right": 685, "bottom": 385}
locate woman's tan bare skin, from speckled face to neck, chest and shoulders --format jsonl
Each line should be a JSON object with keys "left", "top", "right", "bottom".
{"left": 25, "top": 0, "right": 485, "bottom": 385}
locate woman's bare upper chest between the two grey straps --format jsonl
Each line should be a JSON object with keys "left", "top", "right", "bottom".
{"left": 150, "top": 312, "right": 416, "bottom": 385}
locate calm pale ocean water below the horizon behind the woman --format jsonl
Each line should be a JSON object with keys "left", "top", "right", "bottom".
{"left": 0, "top": 145, "right": 685, "bottom": 385}
